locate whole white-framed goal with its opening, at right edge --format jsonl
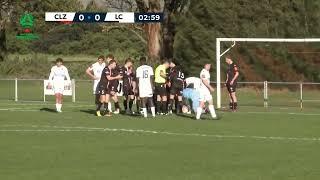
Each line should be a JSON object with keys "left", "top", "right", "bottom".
{"left": 216, "top": 38, "right": 320, "bottom": 108}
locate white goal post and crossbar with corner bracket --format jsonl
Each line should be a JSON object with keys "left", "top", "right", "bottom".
{"left": 216, "top": 38, "right": 320, "bottom": 108}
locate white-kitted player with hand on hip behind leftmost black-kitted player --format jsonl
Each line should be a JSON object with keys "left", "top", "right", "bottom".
{"left": 86, "top": 56, "right": 106, "bottom": 105}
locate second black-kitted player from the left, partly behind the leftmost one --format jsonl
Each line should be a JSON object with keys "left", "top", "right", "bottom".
{"left": 108, "top": 62, "right": 123, "bottom": 114}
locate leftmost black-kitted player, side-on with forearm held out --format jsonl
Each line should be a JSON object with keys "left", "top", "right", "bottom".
{"left": 96, "top": 60, "right": 120, "bottom": 116}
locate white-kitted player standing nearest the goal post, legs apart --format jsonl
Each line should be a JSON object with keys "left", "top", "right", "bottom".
{"left": 197, "top": 64, "right": 217, "bottom": 119}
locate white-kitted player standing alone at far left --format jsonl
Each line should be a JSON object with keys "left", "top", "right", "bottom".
{"left": 49, "top": 58, "right": 71, "bottom": 112}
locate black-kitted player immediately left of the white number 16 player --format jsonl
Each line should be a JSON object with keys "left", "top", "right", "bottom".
{"left": 121, "top": 58, "right": 136, "bottom": 114}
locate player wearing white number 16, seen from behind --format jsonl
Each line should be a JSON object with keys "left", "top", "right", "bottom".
{"left": 136, "top": 57, "right": 155, "bottom": 117}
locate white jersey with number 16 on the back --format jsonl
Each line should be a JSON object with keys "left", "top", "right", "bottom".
{"left": 136, "top": 65, "right": 154, "bottom": 97}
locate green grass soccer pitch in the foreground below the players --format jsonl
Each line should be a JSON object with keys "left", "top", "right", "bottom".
{"left": 0, "top": 101, "right": 320, "bottom": 180}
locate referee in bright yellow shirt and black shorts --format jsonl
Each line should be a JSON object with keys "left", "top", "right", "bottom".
{"left": 154, "top": 60, "right": 170, "bottom": 115}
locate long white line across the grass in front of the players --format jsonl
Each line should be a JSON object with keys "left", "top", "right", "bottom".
{"left": 0, "top": 125, "right": 320, "bottom": 142}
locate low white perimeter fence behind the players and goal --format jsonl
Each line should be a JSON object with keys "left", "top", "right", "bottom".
{"left": 0, "top": 79, "right": 320, "bottom": 108}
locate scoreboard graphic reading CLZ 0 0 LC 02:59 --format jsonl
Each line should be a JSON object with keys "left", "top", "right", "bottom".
{"left": 45, "top": 12, "right": 163, "bottom": 23}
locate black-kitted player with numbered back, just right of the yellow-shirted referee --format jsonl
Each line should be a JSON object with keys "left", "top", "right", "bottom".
{"left": 168, "top": 62, "right": 185, "bottom": 113}
